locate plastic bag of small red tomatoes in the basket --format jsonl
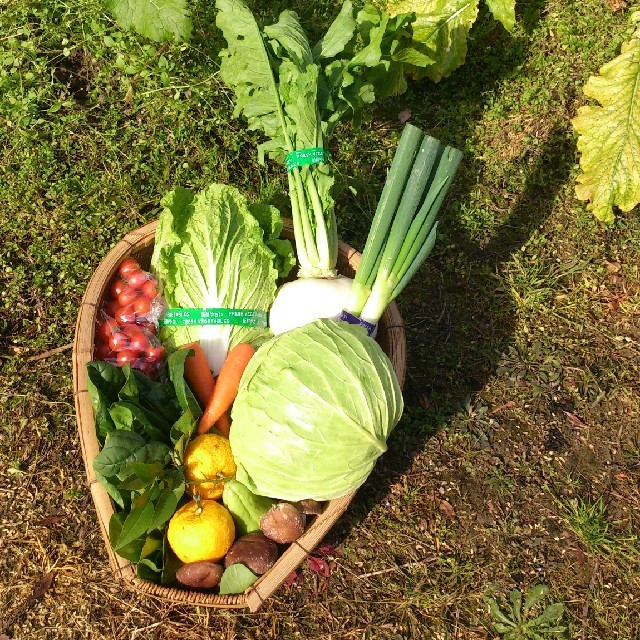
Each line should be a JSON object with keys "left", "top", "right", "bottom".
{"left": 95, "top": 258, "right": 165, "bottom": 378}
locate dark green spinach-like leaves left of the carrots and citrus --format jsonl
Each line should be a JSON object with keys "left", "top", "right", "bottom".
{"left": 88, "top": 350, "right": 201, "bottom": 582}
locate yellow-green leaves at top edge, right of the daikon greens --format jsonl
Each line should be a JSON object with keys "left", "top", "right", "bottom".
{"left": 379, "top": 0, "right": 516, "bottom": 82}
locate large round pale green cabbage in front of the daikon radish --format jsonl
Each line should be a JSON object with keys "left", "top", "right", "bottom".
{"left": 230, "top": 320, "right": 403, "bottom": 501}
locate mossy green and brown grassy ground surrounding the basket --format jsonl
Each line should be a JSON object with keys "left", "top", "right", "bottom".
{"left": 0, "top": 0, "right": 640, "bottom": 640}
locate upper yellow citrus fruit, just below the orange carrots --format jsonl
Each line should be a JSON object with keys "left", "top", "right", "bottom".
{"left": 184, "top": 433, "right": 236, "bottom": 500}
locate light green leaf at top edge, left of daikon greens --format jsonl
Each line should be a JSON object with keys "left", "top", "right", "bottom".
{"left": 106, "top": 0, "right": 192, "bottom": 42}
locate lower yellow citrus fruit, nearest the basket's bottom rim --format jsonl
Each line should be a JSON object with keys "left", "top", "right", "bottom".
{"left": 167, "top": 500, "right": 236, "bottom": 562}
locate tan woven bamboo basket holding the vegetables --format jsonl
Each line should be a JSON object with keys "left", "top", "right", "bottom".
{"left": 73, "top": 220, "right": 406, "bottom": 611}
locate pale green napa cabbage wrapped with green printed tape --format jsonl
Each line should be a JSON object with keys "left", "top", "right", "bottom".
{"left": 151, "top": 184, "right": 290, "bottom": 374}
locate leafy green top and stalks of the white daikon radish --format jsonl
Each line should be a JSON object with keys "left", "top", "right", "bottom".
{"left": 216, "top": 0, "right": 410, "bottom": 277}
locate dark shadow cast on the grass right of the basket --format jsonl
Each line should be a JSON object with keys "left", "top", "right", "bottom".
{"left": 329, "top": 3, "right": 575, "bottom": 544}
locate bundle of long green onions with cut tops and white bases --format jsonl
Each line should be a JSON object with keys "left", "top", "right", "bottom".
{"left": 345, "top": 125, "right": 462, "bottom": 325}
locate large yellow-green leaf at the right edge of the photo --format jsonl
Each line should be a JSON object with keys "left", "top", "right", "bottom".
{"left": 572, "top": 21, "right": 640, "bottom": 222}
